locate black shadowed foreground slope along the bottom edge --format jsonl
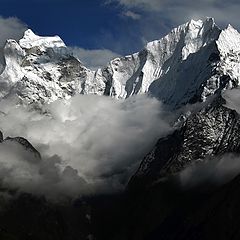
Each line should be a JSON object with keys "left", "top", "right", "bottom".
{"left": 0, "top": 172, "right": 240, "bottom": 240}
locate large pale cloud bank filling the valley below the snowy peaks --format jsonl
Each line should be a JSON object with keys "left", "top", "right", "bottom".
{"left": 0, "top": 95, "right": 171, "bottom": 198}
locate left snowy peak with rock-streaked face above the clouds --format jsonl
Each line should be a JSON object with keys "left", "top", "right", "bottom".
{"left": 0, "top": 30, "right": 97, "bottom": 104}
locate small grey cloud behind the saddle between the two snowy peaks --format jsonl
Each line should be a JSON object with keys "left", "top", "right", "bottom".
{"left": 71, "top": 47, "right": 119, "bottom": 69}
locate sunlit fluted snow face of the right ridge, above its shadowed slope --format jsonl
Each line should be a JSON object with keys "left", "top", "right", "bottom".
{"left": 97, "top": 16, "right": 220, "bottom": 101}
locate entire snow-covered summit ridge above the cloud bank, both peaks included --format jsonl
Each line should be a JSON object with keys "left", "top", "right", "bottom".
{"left": 0, "top": 18, "right": 240, "bottom": 108}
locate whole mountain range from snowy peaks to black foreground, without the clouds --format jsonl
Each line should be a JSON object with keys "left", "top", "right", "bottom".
{"left": 0, "top": 18, "right": 240, "bottom": 240}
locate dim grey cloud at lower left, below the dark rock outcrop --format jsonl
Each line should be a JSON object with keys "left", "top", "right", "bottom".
{"left": 0, "top": 141, "right": 87, "bottom": 201}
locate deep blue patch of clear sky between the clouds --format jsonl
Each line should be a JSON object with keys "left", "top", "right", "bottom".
{"left": 0, "top": 0, "right": 156, "bottom": 54}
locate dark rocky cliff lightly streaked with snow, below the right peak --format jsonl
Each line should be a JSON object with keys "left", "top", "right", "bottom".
{"left": 130, "top": 96, "right": 240, "bottom": 189}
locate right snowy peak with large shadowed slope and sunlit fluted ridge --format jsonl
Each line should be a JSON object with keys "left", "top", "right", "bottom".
{"left": 99, "top": 18, "right": 240, "bottom": 107}
